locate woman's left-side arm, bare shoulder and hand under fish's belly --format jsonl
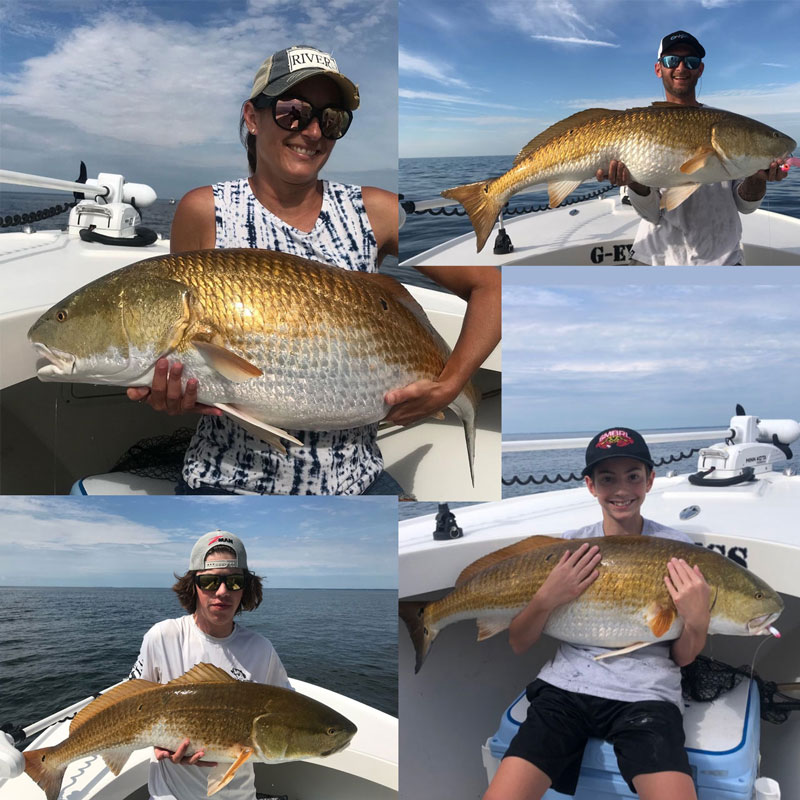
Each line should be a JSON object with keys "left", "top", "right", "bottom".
{"left": 127, "top": 186, "right": 222, "bottom": 416}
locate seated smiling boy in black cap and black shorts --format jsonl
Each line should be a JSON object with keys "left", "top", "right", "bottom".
{"left": 484, "top": 427, "right": 710, "bottom": 800}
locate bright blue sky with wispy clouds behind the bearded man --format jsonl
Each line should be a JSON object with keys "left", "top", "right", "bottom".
{"left": 399, "top": 0, "right": 800, "bottom": 157}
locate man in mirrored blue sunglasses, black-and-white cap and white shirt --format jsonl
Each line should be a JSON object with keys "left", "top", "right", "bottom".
{"left": 597, "top": 31, "right": 786, "bottom": 266}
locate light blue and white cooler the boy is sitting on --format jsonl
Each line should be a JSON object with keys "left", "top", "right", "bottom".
{"left": 482, "top": 681, "right": 761, "bottom": 800}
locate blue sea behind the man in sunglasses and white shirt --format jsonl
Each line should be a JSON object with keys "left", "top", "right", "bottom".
{"left": 400, "top": 155, "right": 800, "bottom": 261}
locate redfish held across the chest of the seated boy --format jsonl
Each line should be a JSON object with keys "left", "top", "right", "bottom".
{"left": 400, "top": 536, "right": 783, "bottom": 672}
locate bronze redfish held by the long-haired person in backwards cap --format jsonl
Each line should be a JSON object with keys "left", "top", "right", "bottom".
{"left": 23, "top": 664, "right": 356, "bottom": 800}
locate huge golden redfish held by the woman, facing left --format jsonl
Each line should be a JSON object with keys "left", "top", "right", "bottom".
{"left": 28, "top": 249, "right": 478, "bottom": 485}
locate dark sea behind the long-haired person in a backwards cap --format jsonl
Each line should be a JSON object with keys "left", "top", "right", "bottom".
{"left": 0, "top": 587, "right": 397, "bottom": 727}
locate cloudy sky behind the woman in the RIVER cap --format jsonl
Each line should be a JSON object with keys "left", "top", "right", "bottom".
{"left": 0, "top": 0, "right": 397, "bottom": 197}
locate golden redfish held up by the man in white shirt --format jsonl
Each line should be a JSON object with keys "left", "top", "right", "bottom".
{"left": 442, "top": 102, "right": 797, "bottom": 252}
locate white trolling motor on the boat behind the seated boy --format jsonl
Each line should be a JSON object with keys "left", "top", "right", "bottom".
{"left": 689, "top": 405, "right": 800, "bottom": 486}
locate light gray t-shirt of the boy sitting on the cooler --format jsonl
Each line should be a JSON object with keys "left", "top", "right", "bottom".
{"left": 538, "top": 519, "right": 692, "bottom": 711}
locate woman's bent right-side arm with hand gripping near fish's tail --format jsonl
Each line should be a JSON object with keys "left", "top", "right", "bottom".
{"left": 385, "top": 266, "right": 500, "bottom": 425}
